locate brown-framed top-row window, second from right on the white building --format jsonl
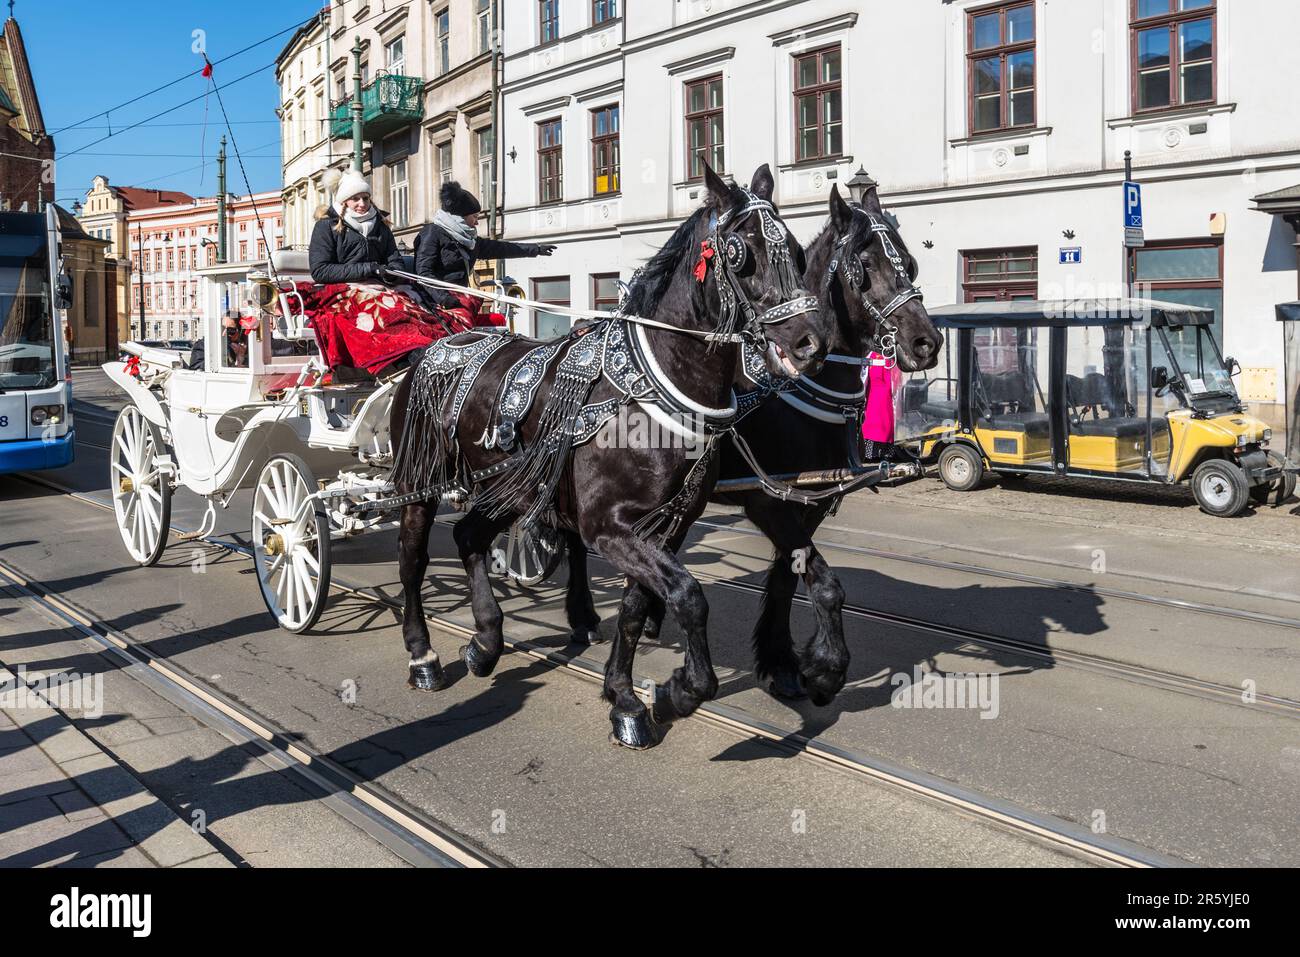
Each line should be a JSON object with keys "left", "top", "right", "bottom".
{"left": 966, "top": 3, "right": 1035, "bottom": 134}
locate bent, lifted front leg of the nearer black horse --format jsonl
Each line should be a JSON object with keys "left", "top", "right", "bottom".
{"left": 598, "top": 536, "right": 718, "bottom": 744}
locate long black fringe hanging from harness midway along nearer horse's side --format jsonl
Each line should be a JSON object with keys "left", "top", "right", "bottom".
{"left": 471, "top": 335, "right": 601, "bottom": 529}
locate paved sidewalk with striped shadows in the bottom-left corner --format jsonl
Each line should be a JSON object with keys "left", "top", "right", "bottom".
{"left": 0, "top": 667, "right": 233, "bottom": 867}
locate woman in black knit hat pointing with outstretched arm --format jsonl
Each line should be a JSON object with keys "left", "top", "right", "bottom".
{"left": 415, "top": 182, "right": 555, "bottom": 307}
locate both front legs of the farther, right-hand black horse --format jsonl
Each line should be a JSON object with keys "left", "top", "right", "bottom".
{"left": 745, "top": 495, "right": 849, "bottom": 705}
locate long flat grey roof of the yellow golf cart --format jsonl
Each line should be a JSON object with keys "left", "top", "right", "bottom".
{"left": 926, "top": 299, "right": 1211, "bottom": 329}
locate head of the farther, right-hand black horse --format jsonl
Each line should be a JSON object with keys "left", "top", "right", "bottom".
{"left": 819, "top": 180, "right": 943, "bottom": 372}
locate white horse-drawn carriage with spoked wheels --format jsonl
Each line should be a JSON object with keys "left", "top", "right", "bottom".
{"left": 104, "top": 251, "right": 559, "bottom": 632}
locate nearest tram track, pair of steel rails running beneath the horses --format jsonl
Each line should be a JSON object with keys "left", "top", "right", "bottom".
{"left": 10, "top": 476, "right": 1190, "bottom": 867}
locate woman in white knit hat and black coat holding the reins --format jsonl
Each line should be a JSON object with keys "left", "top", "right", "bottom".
{"left": 308, "top": 170, "right": 402, "bottom": 282}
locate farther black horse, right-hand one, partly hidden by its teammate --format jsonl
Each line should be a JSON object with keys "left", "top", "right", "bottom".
{"left": 567, "top": 180, "right": 943, "bottom": 705}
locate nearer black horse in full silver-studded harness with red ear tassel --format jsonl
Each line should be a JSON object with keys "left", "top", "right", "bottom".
{"left": 391, "top": 165, "right": 831, "bottom": 748}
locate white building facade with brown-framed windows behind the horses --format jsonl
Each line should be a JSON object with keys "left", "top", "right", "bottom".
{"left": 502, "top": 0, "right": 1300, "bottom": 415}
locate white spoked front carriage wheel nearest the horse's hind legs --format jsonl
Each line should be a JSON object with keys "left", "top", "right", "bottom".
{"left": 252, "top": 455, "right": 330, "bottom": 633}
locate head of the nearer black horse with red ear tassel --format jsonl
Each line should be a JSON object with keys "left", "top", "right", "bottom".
{"left": 697, "top": 163, "right": 829, "bottom": 377}
